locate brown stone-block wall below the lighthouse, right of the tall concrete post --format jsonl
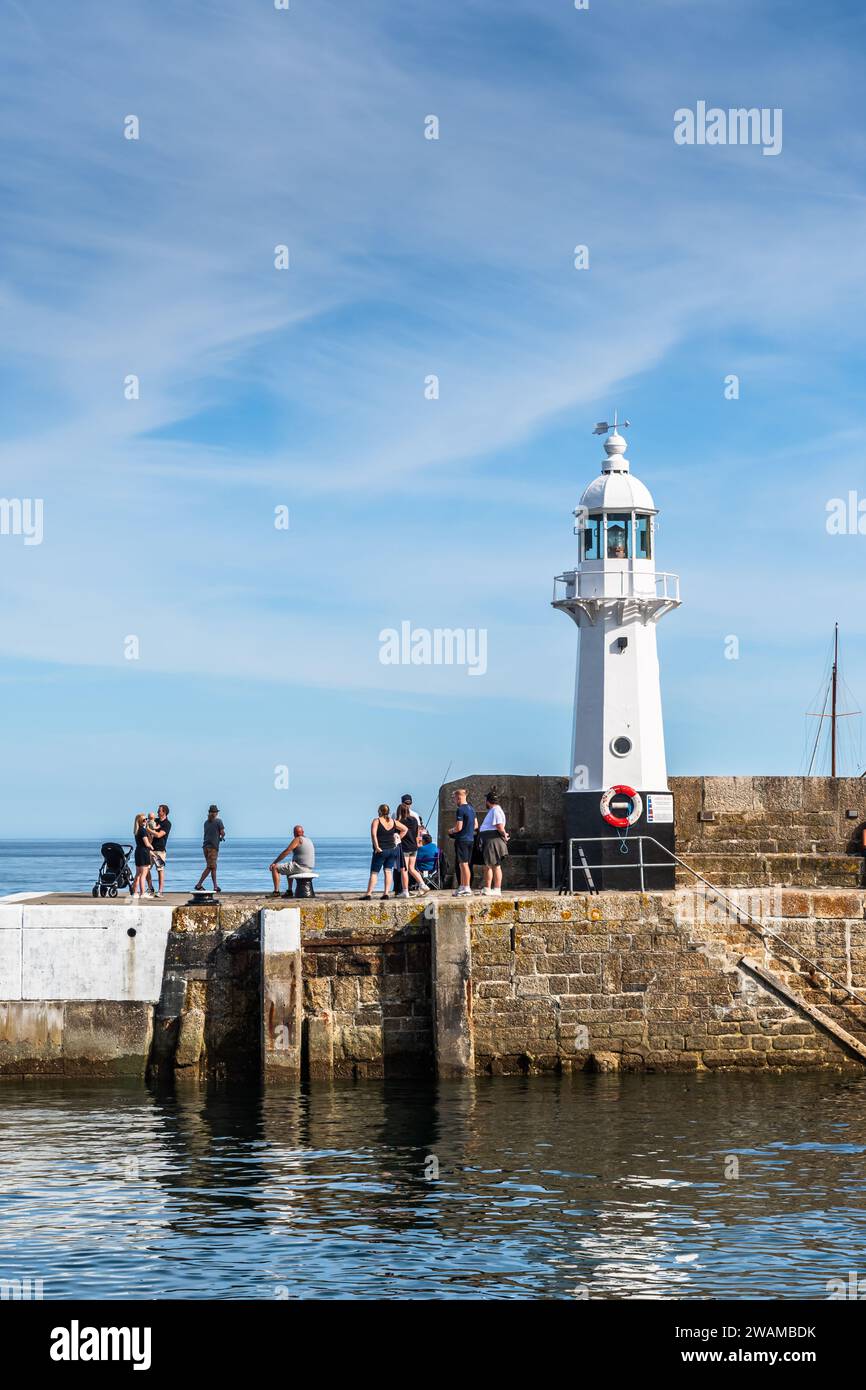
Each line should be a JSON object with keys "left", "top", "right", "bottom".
{"left": 468, "top": 890, "right": 866, "bottom": 1074}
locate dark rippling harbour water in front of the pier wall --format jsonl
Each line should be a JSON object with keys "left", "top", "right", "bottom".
{"left": 0, "top": 1074, "right": 866, "bottom": 1298}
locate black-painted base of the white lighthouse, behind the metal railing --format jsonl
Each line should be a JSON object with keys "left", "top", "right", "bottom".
{"left": 563, "top": 788, "right": 677, "bottom": 892}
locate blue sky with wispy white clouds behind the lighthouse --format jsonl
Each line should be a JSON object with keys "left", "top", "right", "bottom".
{"left": 0, "top": 0, "right": 866, "bottom": 840}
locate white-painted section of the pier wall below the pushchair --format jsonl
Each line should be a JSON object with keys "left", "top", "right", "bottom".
{"left": 0, "top": 899, "right": 171, "bottom": 1004}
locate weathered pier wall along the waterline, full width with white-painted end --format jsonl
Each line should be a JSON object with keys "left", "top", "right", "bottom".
{"left": 0, "top": 888, "right": 866, "bottom": 1084}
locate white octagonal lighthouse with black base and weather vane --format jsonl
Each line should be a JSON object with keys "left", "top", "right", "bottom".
{"left": 553, "top": 416, "right": 680, "bottom": 888}
